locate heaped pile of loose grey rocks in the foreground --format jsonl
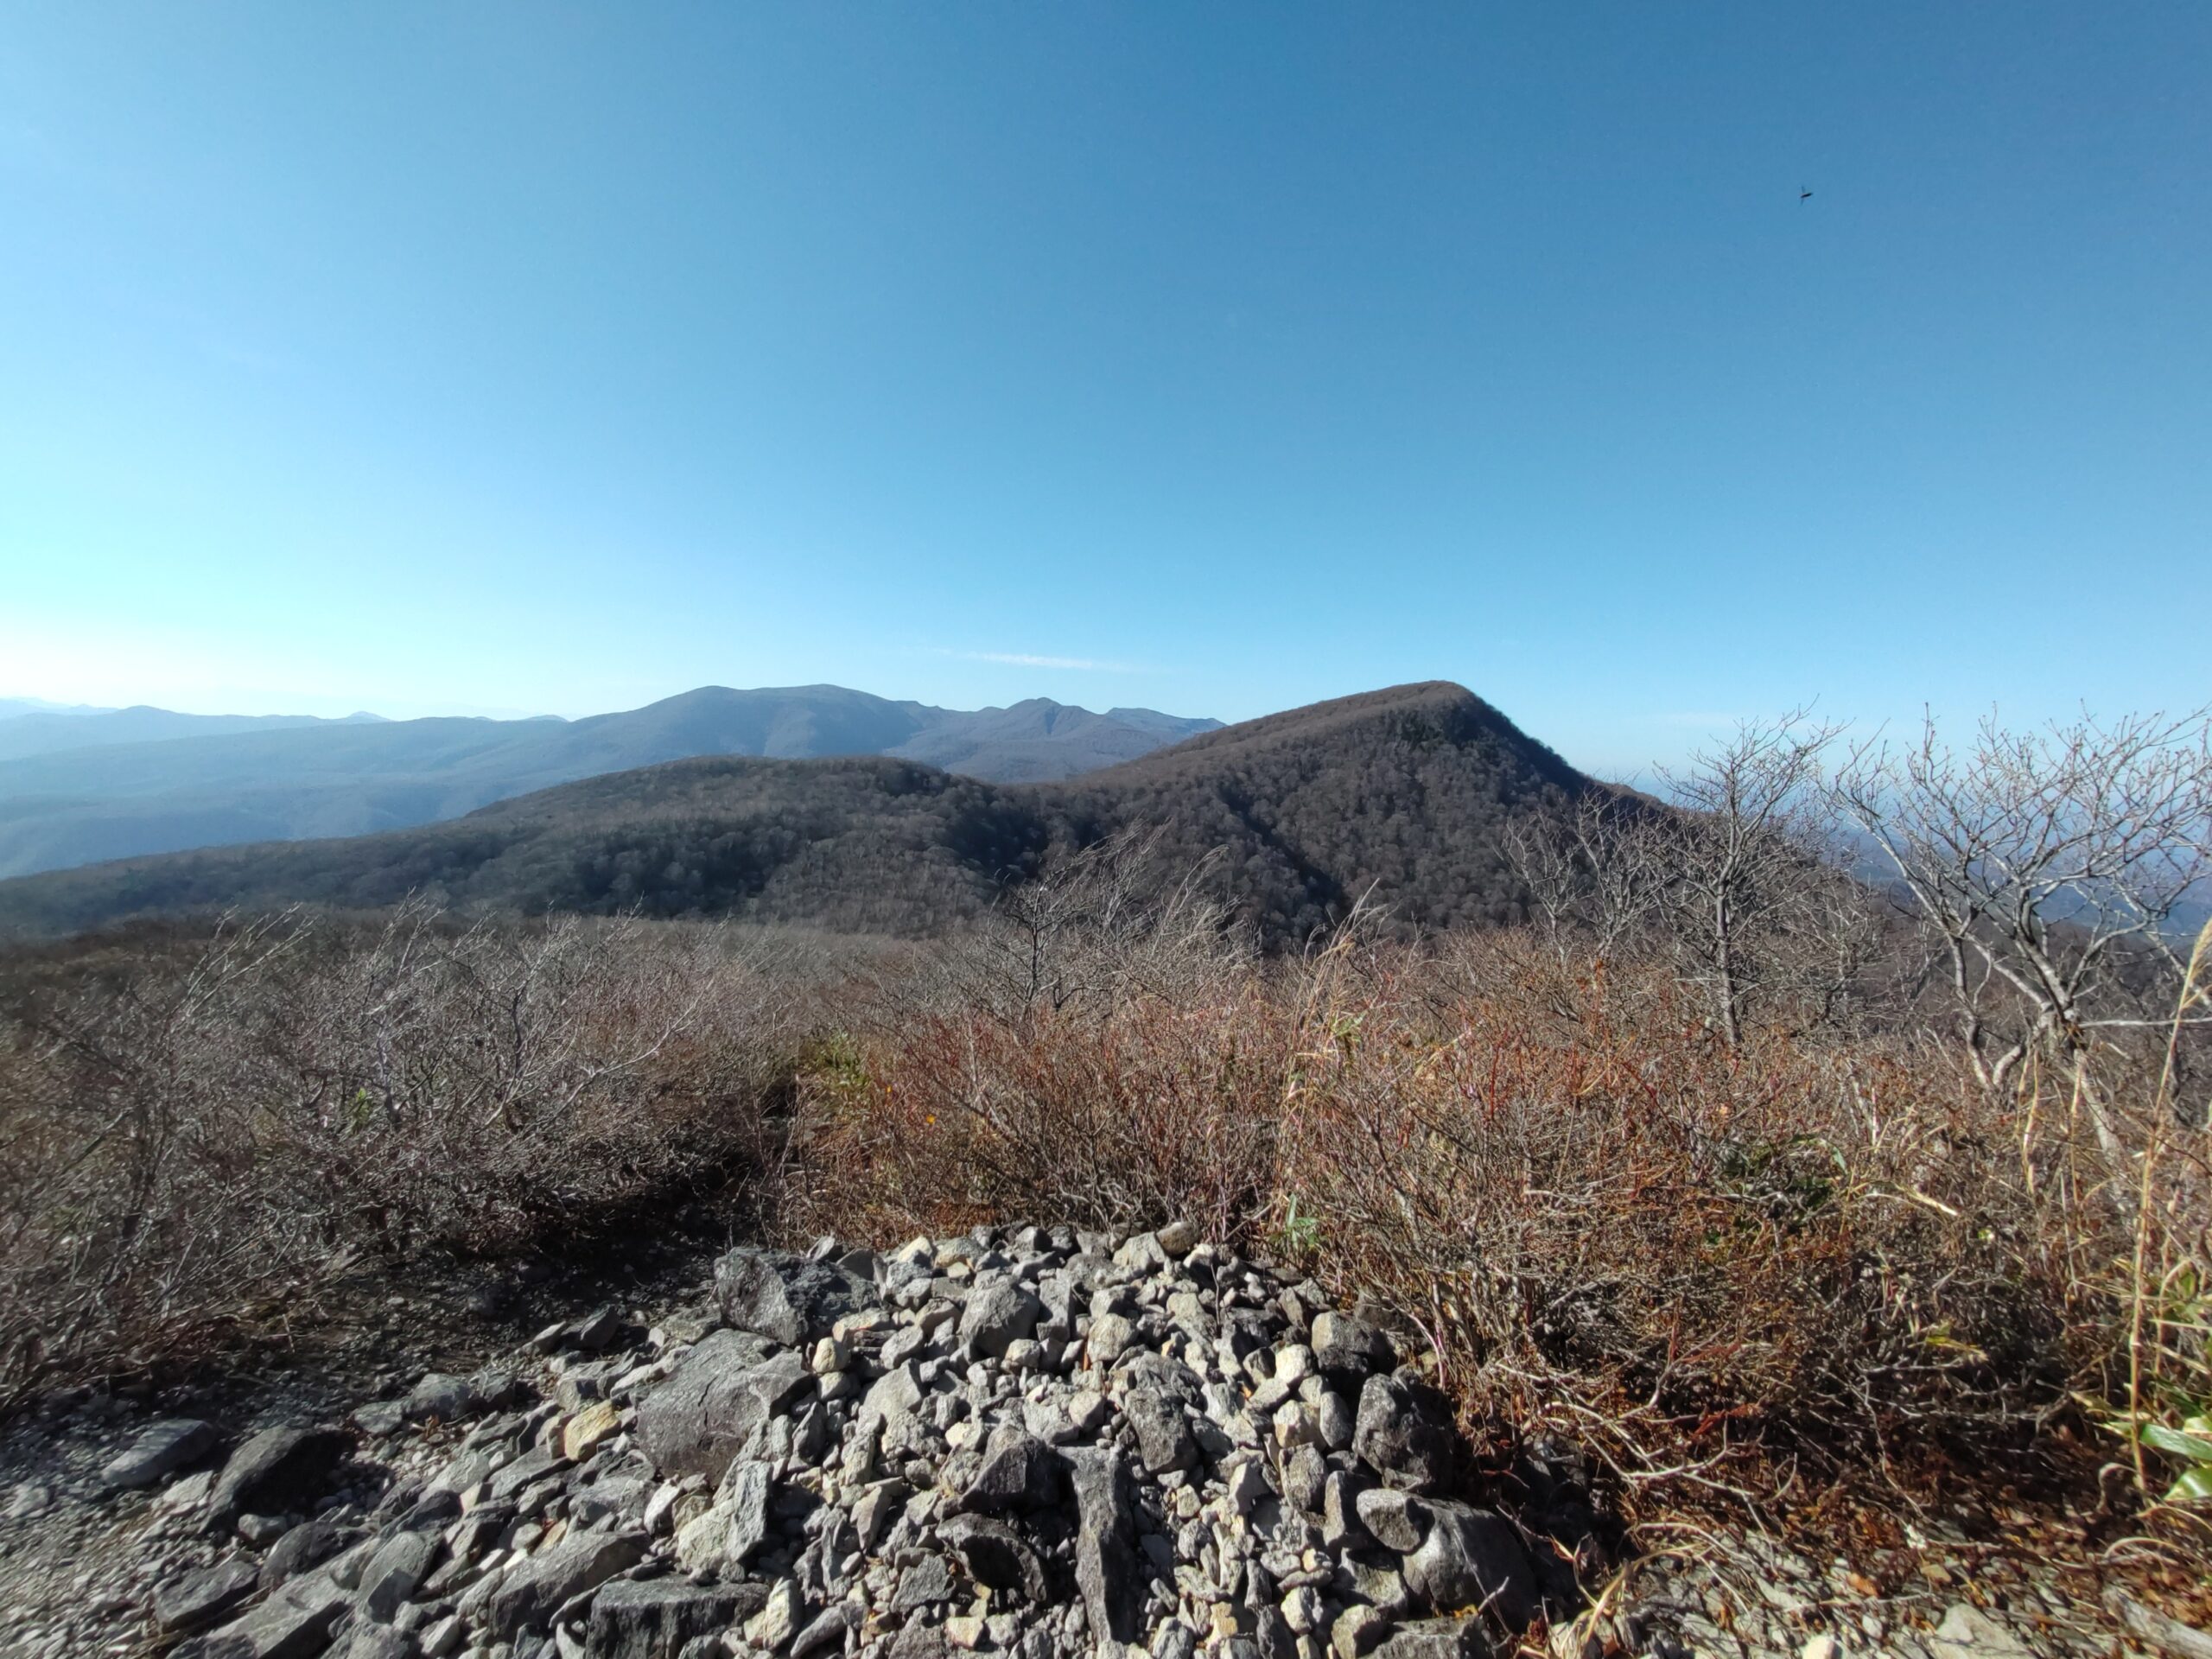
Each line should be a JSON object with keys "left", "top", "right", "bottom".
{"left": 81, "top": 1225, "right": 1573, "bottom": 1659}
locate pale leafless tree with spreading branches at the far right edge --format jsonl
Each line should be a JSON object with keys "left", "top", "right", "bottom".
{"left": 1834, "top": 710, "right": 2212, "bottom": 1096}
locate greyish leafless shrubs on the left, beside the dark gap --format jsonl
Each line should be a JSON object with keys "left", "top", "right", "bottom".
{"left": 0, "top": 905, "right": 790, "bottom": 1394}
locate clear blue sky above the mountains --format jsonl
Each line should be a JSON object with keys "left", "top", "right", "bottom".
{"left": 0, "top": 0, "right": 2212, "bottom": 772}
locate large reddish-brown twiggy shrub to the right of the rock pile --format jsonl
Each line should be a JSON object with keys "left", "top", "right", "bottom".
{"left": 1279, "top": 936, "right": 2079, "bottom": 1502}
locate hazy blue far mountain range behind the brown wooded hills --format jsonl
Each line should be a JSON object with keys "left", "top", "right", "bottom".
{"left": 0, "top": 686, "right": 1221, "bottom": 876}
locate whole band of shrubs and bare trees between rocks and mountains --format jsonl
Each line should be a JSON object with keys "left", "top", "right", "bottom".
{"left": 0, "top": 703, "right": 2212, "bottom": 1574}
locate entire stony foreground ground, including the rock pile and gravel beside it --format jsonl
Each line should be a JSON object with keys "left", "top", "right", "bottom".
{"left": 0, "top": 1228, "right": 2205, "bottom": 1659}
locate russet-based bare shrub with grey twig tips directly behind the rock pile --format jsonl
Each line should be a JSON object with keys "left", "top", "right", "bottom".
{"left": 807, "top": 842, "right": 1289, "bottom": 1236}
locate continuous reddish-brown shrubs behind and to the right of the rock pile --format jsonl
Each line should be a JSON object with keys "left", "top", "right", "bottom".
{"left": 791, "top": 933, "right": 2167, "bottom": 1504}
